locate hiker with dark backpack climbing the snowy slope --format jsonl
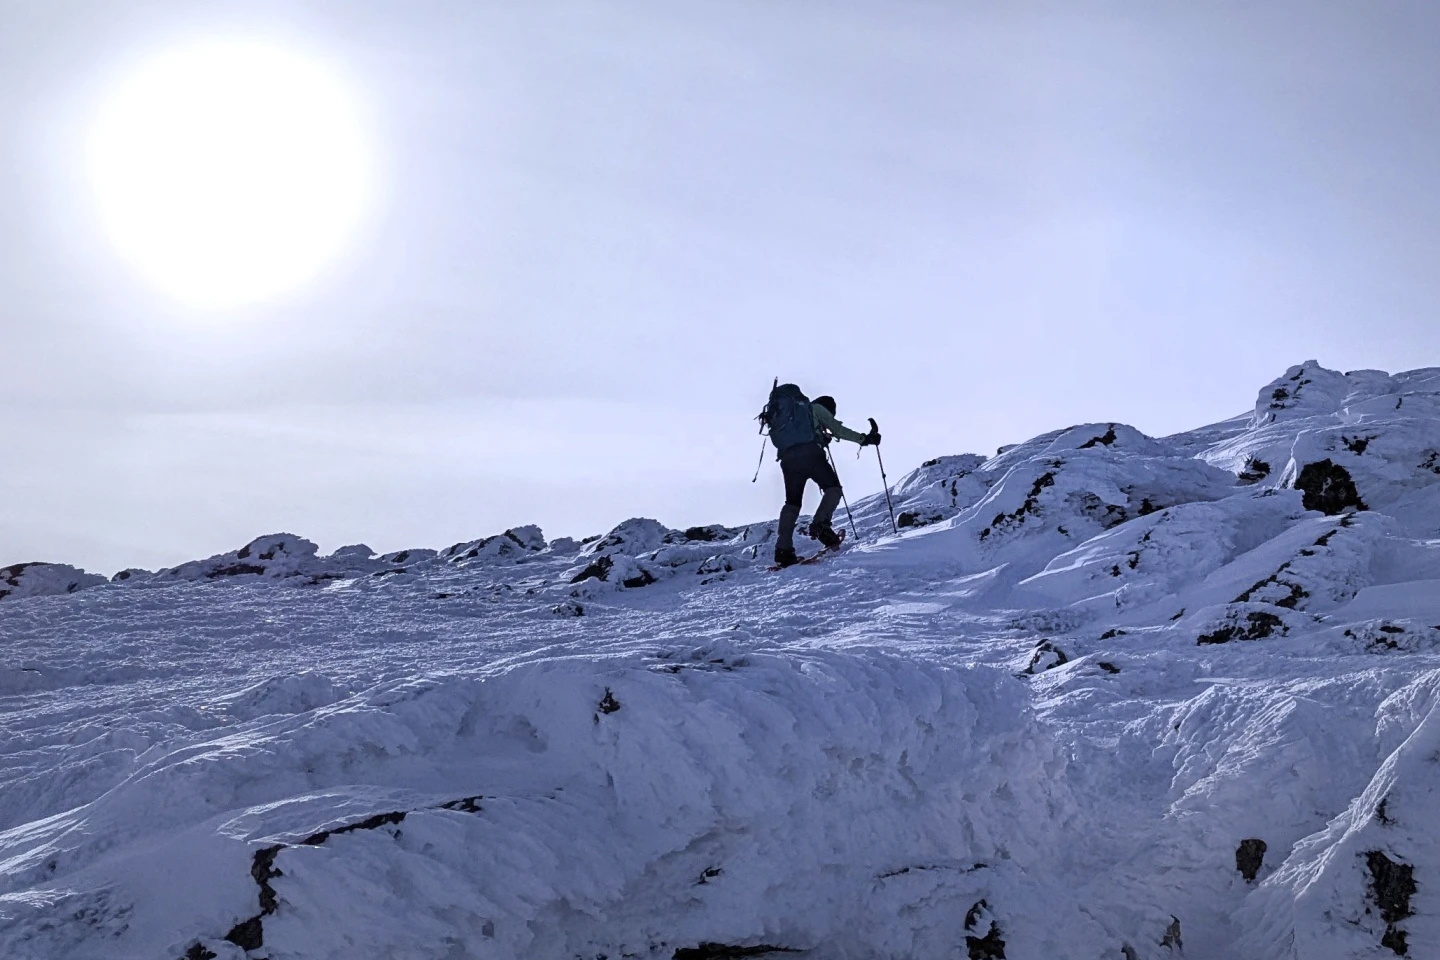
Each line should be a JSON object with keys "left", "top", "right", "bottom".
{"left": 760, "top": 383, "right": 880, "bottom": 567}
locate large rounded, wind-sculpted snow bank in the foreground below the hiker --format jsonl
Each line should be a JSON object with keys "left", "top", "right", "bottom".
{"left": 0, "top": 649, "right": 1116, "bottom": 960}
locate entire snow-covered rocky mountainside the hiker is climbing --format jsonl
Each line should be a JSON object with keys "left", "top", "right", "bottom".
{"left": 0, "top": 363, "right": 1440, "bottom": 960}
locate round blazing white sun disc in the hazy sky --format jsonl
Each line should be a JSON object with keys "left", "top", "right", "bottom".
{"left": 89, "top": 42, "right": 370, "bottom": 307}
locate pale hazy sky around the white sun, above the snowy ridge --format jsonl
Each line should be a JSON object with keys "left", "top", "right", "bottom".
{"left": 0, "top": 0, "right": 1440, "bottom": 573}
